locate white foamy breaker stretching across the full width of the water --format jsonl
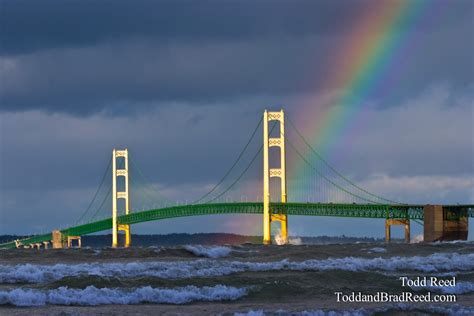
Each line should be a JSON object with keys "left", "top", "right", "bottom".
{"left": 0, "top": 253, "right": 474, "bottom": 283}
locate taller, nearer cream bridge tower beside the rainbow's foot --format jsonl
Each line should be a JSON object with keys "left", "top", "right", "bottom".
{"left": 263, "top": 110, "right": 288, "bottom": 245}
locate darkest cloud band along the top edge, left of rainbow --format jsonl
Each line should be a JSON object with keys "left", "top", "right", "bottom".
{"left": 0, "top": 0, "right": 378, "bottom": 55}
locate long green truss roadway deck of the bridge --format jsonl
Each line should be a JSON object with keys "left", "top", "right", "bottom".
{"left": 0, "top": 202, "right": 474, "bottom": 248}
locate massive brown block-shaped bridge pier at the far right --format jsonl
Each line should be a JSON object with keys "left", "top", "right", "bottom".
{"left": 423, "top": 205, "right": 469, "bottom": 242}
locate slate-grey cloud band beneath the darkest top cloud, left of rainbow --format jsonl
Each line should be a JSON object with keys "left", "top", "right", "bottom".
{"left": 3, "top": 37, "right": 331, "bottom": 113}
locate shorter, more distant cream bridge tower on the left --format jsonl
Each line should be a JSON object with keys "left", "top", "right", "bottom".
{"left": 112, "top": 148, "right": 131, "bottom": 248}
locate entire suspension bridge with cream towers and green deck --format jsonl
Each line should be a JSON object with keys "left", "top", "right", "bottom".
{"left": 0, "top": 110, "right": 474, "bottom": 248}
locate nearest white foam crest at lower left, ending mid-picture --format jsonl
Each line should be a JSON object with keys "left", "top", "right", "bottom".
{"left": 0, "top": 285, "right": 248, "bottom": 306}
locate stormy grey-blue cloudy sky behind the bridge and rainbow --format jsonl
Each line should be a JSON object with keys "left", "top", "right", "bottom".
{"left": 0, "top": 0, "right": 474, "bottom": 237}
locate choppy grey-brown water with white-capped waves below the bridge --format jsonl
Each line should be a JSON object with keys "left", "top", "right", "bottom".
{"left": 0, "top": 242, "right": 474, "bottom": 315}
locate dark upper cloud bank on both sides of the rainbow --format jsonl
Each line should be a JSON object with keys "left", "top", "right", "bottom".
{"left": 0, "top": 1, "right": 474, "bottom": 115}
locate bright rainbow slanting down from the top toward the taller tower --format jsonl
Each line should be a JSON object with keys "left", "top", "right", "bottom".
{"left": 288, "top": 0, "right": 439, "bottom": 200}
